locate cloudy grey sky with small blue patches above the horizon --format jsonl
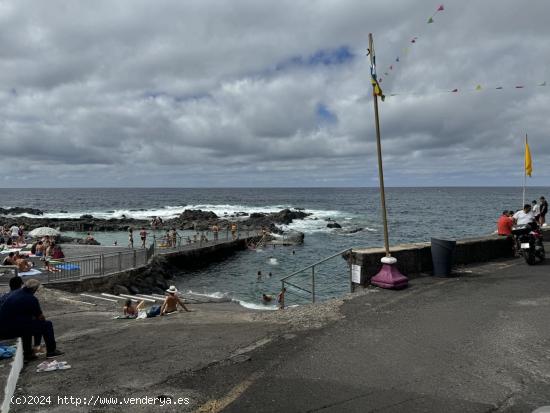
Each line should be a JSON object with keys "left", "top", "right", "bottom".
{"left": 0, "top": 0, "right": 550, "bottom": 188}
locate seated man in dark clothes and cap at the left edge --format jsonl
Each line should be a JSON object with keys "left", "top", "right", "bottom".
{"left": 0, "top": 279, "right": 63, "bottom": 361}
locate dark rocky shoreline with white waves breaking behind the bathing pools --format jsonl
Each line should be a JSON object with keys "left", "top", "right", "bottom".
{"left": 0, "top": 207, "right": 311, "bottom": 234}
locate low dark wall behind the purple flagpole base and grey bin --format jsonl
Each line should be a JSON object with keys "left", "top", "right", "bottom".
{"left": 347, "top": 235, "right": 513, "bottom": 282}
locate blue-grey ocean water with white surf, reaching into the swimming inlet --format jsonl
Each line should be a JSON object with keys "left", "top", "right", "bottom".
{"left": 0, "top": 187, "right": 550, "bottom": 309}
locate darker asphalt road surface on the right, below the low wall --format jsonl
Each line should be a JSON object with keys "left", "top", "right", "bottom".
{"left": 190, "top": 253, "right": 550, "bottom": 413}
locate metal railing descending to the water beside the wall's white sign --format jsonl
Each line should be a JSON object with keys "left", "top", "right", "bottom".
{"left": 279, "top": 248, "right": 353, "bottom": 308}
